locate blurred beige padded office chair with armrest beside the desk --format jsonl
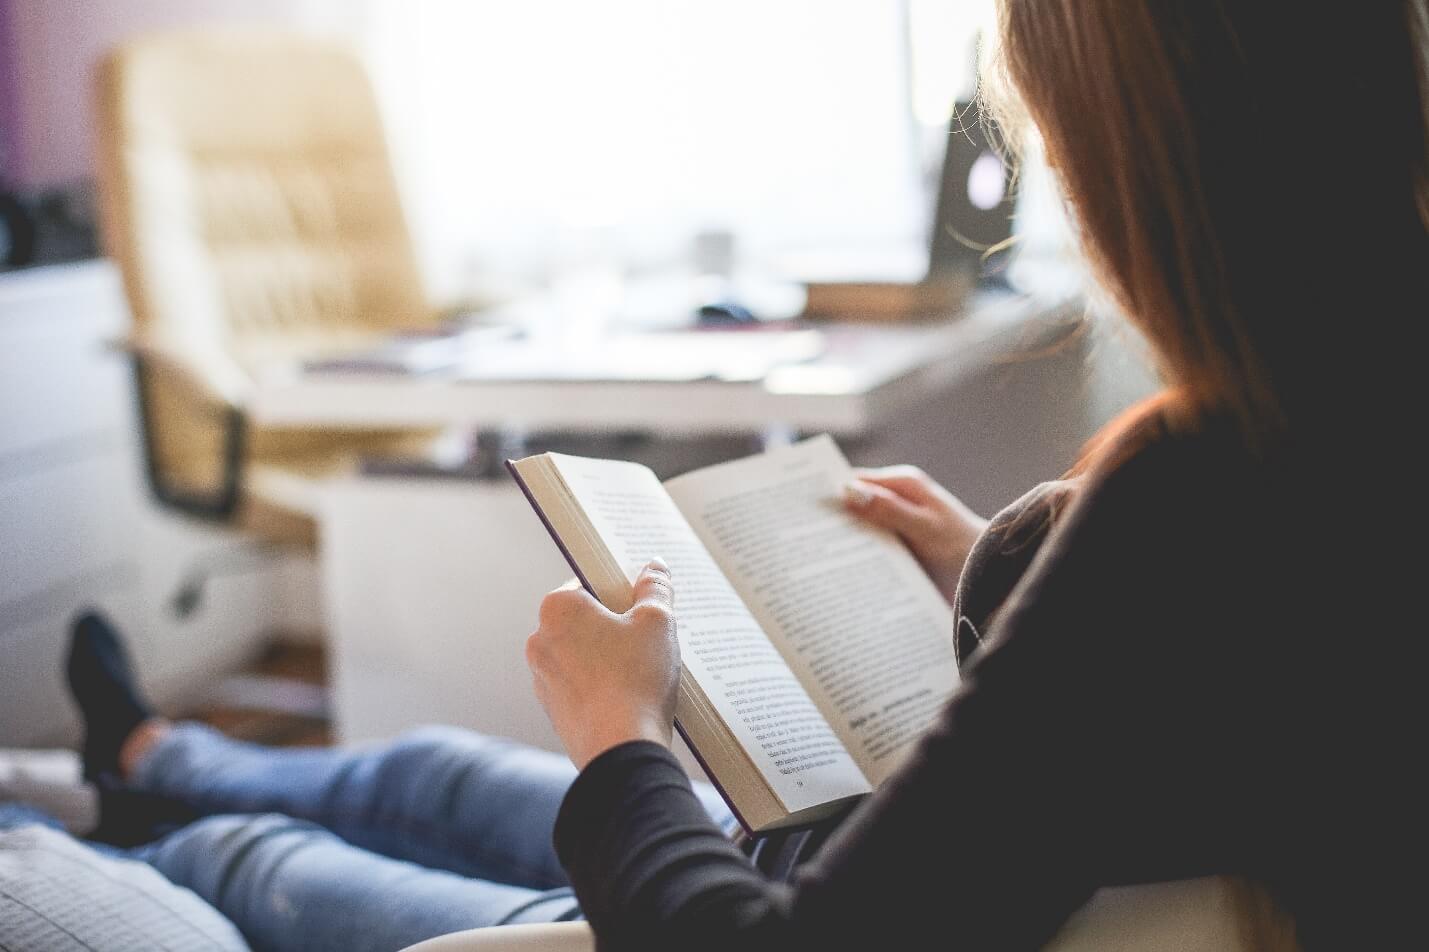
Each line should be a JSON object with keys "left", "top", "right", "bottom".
{"left": 99, "top": 29, "right": 437, "bottom": 545}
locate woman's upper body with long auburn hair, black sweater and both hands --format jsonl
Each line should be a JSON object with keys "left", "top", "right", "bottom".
{"left": 527, "top": 0, "right": 1429, "bottom": 949}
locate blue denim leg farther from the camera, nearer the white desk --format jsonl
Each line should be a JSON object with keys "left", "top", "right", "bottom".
{"left": 133, "top": 725, "right": 735, "bottom": 889}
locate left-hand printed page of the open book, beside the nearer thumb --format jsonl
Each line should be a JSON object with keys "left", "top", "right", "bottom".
{"left": 550, "top": 453, "right": 869, "bottom": 812}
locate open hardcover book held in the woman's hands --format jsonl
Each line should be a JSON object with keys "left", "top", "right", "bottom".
{"left": 507, "top": 436, "right": 957, "bottom": 833}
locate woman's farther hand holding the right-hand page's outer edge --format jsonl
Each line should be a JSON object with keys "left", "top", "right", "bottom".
{"left": 843, "top": 466, "right": 987, "bottom": 605}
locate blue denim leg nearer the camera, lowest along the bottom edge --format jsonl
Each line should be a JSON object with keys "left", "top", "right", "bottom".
{"left": 130, "top": 815, "right": 579, "bottom": 952}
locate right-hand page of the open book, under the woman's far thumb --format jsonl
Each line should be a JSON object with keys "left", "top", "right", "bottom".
{"left": 666, "top": 436, "right": 957, "bottom": 786}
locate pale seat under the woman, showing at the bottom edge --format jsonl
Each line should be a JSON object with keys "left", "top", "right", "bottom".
{"left": 407, "top": 876, "right": 1255, "bottom": 952}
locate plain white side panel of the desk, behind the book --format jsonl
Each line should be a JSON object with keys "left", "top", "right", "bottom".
{"left": 320, "top": 477, "right": 570, "bottom": 750}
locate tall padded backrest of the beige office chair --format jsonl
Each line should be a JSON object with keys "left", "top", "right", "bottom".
{"left": 100, "top": 30, "right": 432, "bottom": 348}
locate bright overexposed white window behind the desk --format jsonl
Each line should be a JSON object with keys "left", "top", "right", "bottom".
{"left": 349, "top": 0, "right": 1068, "bottom": 294}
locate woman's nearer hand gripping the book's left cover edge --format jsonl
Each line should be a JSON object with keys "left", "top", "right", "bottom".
{"left": 526, "top": 559, "right": 680, "bottom": 769}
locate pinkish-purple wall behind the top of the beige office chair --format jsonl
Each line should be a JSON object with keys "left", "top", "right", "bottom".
{"left": 0, "top": 0, "right": 302, "bottom": 186}
